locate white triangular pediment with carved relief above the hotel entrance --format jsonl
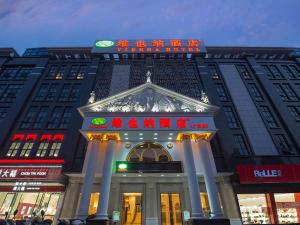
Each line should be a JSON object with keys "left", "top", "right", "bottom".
{"left": 78, "top": 82, "right": 218, "bottom": 116}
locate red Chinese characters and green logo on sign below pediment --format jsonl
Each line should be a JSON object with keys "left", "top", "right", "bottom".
{"left": 88, "top": 117, "right": 208, "bottom": 130}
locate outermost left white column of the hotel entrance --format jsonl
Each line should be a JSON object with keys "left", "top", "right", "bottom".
{"left": 76, "top": 141, "right": 99, "bottom": 219}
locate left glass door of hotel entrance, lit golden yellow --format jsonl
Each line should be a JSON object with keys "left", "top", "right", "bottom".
{"left": 122, "top": 193, "right": 143, "bottom": 225}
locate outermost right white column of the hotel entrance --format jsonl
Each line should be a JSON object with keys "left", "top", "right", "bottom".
{"left": 198, "top": 140, "right": 224, "bottom": 218}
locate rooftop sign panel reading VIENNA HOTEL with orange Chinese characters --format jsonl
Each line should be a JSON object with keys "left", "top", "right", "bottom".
{"left": 92, "top": 39, "right": 206, "bottom": 54}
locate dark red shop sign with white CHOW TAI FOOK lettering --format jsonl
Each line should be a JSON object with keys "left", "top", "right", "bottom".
{"left": 0, "top": 167, "right": 61, "bottom": 180}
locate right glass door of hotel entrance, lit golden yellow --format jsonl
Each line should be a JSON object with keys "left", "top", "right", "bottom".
{"left": 160, "top": 193, "right": 182, "bottom": 225}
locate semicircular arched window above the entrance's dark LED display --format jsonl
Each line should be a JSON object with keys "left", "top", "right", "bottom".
{"left": 127, "top": 142, "right": 172, "bottom": 162}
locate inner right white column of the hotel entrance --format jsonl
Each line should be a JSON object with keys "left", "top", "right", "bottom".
{"left": 182, "top": 139, "right": 203, "bottom": 219}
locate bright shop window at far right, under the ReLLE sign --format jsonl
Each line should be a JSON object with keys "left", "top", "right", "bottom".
{"left": 274, "top": 193, "right": 300, "bottom": 224}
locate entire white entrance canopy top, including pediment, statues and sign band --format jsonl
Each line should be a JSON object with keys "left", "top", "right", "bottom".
{"left": 78, "top": 72, "right": 218, "bottom": 141}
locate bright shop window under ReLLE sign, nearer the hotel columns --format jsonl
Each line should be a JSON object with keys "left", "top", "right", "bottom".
{"left": 238, "top": 194, "right": 270, "bottom": 224}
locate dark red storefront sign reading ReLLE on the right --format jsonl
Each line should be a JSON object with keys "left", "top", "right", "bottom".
{"left": 237, "top": 165, "right": 300, "bottom": 184}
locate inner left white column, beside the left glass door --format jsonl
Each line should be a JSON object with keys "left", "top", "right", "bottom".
{"left": 94, "top": 140, "right": 116, "bottom": 220}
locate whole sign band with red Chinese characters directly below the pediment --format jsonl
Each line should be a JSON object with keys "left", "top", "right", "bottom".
{"left": 83, "top": 117, "right": 215, "bottom": 131}
